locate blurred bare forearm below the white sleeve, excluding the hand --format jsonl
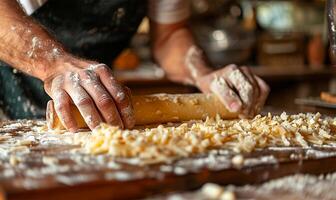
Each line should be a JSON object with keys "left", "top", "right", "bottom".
{"left": 151, "top": 22, "right": 212, "bottom": 85}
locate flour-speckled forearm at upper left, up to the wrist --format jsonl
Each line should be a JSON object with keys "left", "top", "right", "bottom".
{"left": 0, "top": 0, "right": 75, "bottom": 80}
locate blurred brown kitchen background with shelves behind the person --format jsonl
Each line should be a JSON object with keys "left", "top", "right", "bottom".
{"left": 112, "top": 0, "right": 336, "bottom": 114}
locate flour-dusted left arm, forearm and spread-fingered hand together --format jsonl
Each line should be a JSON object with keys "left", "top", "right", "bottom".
{"left": 0, "top": 0, "right": 134, "bottom": 132}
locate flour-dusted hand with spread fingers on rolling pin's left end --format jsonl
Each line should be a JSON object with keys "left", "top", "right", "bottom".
{"left": 44, "top": 56, "right": 135, "bottom": 132}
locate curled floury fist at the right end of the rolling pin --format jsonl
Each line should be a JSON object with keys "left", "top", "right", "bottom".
{"left": 196, "top": 65, "right": 270, "bottom": 118}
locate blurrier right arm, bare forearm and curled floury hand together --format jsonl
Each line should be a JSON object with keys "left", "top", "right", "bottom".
{"left": 151, "top": 21, "right": 269, "bottom": 118}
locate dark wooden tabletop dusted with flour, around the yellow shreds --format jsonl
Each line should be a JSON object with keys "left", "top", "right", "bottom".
{"left": 0, "top": 118, "right": 336, "bottom": 199}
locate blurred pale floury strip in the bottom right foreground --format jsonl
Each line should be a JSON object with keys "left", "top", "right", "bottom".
{"left": 147, "top": 173, "right": 336, "bottom": 200}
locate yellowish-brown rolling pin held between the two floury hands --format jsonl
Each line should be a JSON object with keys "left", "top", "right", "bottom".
{"left": 46, "top": 93, "right": 238, "bottom": 130}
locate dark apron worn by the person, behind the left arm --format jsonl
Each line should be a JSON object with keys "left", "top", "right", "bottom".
{"left": 0, "top": 0, "right": 147, "bottom": 119}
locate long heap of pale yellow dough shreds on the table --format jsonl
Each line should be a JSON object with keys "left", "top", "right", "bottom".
{"left": 75, "top": 113, "right": 336, "bottom": 164}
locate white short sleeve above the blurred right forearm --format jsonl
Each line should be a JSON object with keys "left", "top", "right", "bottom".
{"left": 148, "top": 0, "right": 190, "bottom": 24}
